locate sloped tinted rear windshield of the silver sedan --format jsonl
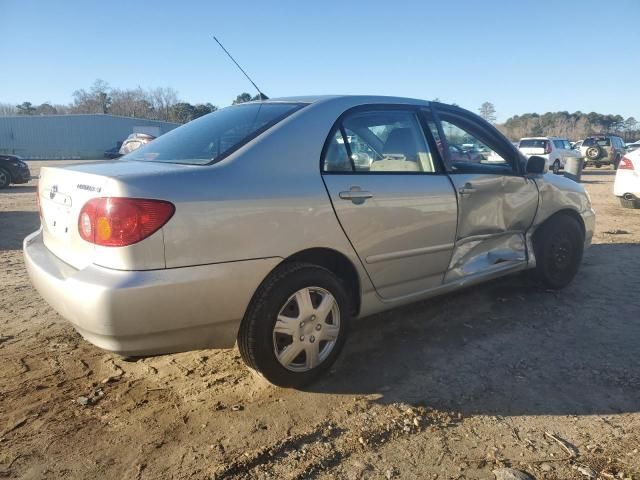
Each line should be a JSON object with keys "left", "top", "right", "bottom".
{"left": 122, "top": 103, "right": 304, "bottom": 165}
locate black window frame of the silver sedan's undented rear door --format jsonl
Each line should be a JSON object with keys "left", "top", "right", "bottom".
{"left": 320, "top": 103, "right": 446, "bottom": 175}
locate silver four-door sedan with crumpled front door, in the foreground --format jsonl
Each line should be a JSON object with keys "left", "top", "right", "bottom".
{"left": 24, "top": 96, "right": 595, "bottom": 386}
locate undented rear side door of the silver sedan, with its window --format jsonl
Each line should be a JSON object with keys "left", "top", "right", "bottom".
{"left": 322, "top": 105, "right": 457, "bottom": 298}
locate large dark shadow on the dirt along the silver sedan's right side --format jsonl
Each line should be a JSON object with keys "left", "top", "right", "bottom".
{"left": 310, "top": 244, "right": 640, "bottom": 415}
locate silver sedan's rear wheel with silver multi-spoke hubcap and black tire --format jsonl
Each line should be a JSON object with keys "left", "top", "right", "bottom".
{"left": 238, "top": 263, "right": 351, "bottom": 388}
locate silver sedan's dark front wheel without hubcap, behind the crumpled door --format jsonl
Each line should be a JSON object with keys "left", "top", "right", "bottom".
{"left": 533, "top": 214, "right": 584, "bottom": 290}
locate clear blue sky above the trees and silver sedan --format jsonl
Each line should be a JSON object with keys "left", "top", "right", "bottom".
{"left": 0, "top": 0, "right": 640, "bottom": 120}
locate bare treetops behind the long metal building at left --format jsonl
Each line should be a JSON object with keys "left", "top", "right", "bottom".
{"left": 0, "top": 79, "right": 258, "bottom": 123}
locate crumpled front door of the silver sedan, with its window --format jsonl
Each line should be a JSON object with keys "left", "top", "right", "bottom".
{"left": 429, "top": 105, "right": 538, "bottom": 282}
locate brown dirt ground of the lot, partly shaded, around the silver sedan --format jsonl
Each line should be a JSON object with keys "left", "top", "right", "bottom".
{"left": 0, "top": 162, "right": 640, "bottom": 479}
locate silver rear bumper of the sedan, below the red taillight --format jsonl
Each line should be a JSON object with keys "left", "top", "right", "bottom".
{"left": 23, "top": 231, "right": 281, "bottom": 356}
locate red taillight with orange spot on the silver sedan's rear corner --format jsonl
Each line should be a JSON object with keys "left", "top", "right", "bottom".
{"left": 78, "top": 197, "right": 176, "bottom": 247}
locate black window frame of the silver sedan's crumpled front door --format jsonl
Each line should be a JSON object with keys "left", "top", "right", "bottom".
{"left": 432, "top": 104, "right": 526, "bottom": 177}
